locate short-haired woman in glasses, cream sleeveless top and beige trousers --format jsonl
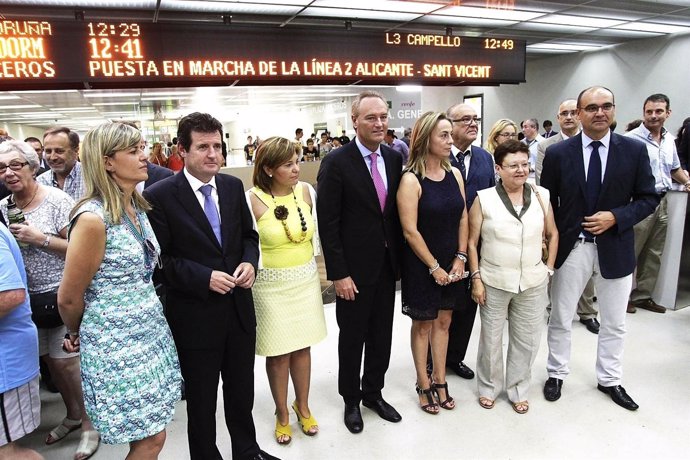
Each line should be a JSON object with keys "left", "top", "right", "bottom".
{"left": 467, "top": 140, "right": 558, "bottom": 414}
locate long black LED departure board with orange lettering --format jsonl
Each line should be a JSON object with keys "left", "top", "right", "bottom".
{"left": 0, "top": 19, "right": 525, "bottom": 89}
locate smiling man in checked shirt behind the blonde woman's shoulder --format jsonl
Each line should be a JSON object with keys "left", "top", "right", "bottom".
{"left": 36, "top": 127, "right": 86, "bottom": 201}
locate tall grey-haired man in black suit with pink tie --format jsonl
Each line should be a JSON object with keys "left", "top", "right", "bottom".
{"left": 316, "top": 91, "right": 402, "bottom": 433}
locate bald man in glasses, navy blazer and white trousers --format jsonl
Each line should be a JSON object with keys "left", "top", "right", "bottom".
{"left": 541, "top": 86, "right": 659, "bottom": 410}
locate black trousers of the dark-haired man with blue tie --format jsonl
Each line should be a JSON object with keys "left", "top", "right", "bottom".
{"left": 177, "top": 294, "right": 259, "bottom": 460}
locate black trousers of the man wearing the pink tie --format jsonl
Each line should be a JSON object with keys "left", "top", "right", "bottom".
{"left": 335, "top": 262, "right": 395, "bottom": 404}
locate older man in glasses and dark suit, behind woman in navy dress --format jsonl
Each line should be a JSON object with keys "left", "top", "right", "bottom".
{"left": 446, "top": 104, "right": 496, "bottom": 379}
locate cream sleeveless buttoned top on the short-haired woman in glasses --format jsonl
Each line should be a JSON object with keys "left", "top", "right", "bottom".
{"left": 477, "top": 187, "right": 549, "bottom": 293}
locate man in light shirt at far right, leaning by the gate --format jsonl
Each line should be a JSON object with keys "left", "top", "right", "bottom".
{"left": 625, "top": 94, "right": 690, "bottom": 313}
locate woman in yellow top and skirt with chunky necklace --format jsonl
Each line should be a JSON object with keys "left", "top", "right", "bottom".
{"left": 247, "top": 137, "right": 326, "bottom": 444}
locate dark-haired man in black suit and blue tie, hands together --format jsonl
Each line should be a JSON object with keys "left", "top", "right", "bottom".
{"left": 144, "top": 112, "right": 275, "bottom": 460}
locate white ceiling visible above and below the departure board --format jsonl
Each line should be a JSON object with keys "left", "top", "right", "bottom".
{"left": 0, "top": 0, "right": 690, "bottom": 130}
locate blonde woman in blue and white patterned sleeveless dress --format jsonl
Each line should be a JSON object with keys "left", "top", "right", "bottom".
{"left": 58, "top": 123, "right": 181, "bottom": 459}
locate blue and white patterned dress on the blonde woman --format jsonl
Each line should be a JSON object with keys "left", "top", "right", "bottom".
{"left": 72, "top": 200, "right": 181, "bottom": 444}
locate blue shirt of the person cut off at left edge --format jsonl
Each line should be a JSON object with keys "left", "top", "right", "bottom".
{"left": 0, "top": 225, "right": 38, "bottom": 393}
